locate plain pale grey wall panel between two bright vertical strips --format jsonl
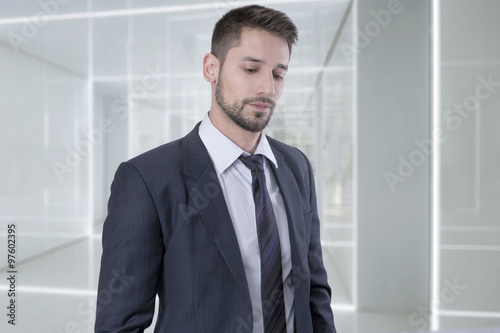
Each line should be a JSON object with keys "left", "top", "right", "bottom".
{"left": 357, "top": 0, "right": 430, "bottom": 312}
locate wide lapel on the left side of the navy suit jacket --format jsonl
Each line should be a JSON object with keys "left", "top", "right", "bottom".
{"left": 184, "top": 123, "right": 250, "bottom": 302}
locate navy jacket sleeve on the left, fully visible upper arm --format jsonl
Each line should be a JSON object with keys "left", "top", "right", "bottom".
{"left": 95, "top": 162, "right": 163, "bottom": 333}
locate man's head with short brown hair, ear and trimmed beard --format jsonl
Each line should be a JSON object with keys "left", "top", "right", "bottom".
{"left": 203, "top": 5, "right": 297, "bottom": 133}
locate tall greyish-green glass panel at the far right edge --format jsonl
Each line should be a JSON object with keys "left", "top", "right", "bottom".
{"left": 438, "top": 0, "right": 500, "bottom": 316}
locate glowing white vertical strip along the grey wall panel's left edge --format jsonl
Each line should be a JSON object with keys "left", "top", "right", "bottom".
{"left": 352, "top": 0, "right": 358, "bottom": 310}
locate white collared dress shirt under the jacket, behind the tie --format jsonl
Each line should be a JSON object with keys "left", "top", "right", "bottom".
{"left": 198, "top": 113, "right": 295, "bottom": 333}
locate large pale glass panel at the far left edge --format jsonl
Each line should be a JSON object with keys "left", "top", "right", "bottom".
{"left": 0, "top": 21, "right": 92, "bottom": 245}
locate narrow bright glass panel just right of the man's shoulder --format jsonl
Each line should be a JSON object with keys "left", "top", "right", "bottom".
{"left": 316, "top": 9, "right": 356, "bottom": 305}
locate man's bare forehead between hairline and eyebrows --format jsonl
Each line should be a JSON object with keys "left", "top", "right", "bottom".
{"left": 226, "top": 28, "right": 290, "bottom": 66}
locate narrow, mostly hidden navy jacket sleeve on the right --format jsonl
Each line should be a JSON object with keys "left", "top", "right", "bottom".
{"left": 306, "top": 154, "right": 336, "bottom": 333}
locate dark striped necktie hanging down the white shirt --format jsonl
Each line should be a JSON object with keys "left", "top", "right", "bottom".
{"left": 239, "top": 155, "right": 286, "bottom": 333}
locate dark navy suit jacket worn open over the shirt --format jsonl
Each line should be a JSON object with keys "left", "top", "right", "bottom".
{"left": 95, "top": 124, "right": 335, "bottom": 333}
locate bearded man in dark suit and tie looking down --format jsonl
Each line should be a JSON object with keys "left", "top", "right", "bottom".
{"left": 95, "top": 5, "right": 335, "bottom": 333}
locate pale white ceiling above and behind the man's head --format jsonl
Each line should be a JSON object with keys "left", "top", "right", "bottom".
{"left": 0, "top": 0, "right": 348, "bottom": 80}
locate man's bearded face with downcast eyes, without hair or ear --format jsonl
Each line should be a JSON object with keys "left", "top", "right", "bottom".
{"left": 215, "top": 29, "right": 290, "bottom": 132}
